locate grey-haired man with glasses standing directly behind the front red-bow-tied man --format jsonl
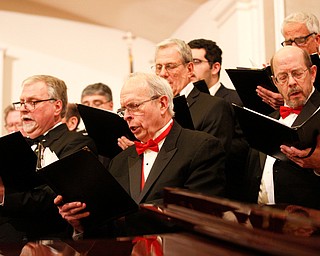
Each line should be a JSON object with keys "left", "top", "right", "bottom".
{"left": 118, "top": 39, "right": 235, "bottom": 156}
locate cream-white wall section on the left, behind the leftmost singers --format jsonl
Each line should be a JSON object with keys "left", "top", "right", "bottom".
{"left": 0, "top": 11, "right": 154, "bottom": 134}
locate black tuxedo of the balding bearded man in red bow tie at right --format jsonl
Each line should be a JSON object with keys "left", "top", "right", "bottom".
{"left": 246, "top": 91, "right": 320, "bottom": 209}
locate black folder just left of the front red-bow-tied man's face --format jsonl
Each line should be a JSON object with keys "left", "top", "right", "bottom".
{"left": 77, "top": 104, "right": 136, "bottom": 158}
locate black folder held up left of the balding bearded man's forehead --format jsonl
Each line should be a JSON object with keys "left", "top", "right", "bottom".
{"left": 226, "top": 66, "right": 278, "bottom": 115}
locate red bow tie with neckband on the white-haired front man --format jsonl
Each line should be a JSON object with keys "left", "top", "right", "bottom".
{"left": 134, "top": 122, "right": 173, "bottom": 190}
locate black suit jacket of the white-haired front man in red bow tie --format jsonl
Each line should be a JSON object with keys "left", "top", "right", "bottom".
{"left": 109, "top": 122, "right": 225, "bottom": 203}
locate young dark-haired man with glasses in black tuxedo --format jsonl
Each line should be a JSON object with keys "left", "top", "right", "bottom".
{"left": 188, "top": 39, "right": 249, "bottom": 199}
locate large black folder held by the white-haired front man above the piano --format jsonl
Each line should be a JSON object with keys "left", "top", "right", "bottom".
{"left": 38, "top": 149, "right": 138, "bottom": 227}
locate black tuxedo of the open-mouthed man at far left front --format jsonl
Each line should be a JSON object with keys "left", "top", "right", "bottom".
{"left": 0, "top": 124, "right": 97, "bottom": 240}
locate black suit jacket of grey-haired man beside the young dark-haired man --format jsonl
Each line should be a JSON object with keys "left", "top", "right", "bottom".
{"left": 187, "top": 88, "right": 234, "bottom": 152}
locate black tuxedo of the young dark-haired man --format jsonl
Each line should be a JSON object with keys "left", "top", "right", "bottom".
{"left": 215, "top": 83, "right": 249, "bottom": 200}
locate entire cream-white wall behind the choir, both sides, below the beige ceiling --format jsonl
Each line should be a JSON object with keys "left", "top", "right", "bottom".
{"left": 0, "top": 0, "right": 319, "bottom": 133}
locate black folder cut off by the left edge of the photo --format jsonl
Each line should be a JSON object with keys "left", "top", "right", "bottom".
{"left": 0, "top": 132, "right": 43, "bottom": 191}
